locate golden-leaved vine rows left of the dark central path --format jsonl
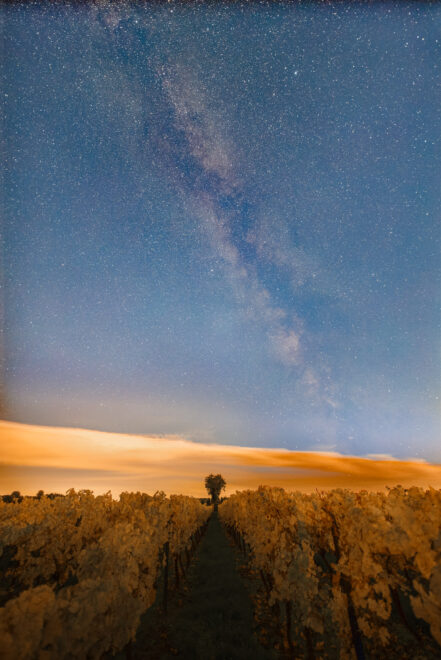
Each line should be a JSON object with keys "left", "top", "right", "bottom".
{"left": 0, "top": 490, "right": 211, "bottom": 660}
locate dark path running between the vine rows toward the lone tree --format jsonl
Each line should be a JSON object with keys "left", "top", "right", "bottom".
{"left": 118, "top": 515, "right": 277, "bottom": 660}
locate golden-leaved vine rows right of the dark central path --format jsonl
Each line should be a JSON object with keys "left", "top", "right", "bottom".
{"left": 219, "top": 487, "right": 441, "bottom": 660}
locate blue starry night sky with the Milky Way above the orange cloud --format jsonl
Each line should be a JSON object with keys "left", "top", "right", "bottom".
{"left": 1, "top": 1, "right": 441, "bottom": 461}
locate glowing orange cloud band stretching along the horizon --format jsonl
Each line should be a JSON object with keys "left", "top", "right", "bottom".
{"left": 0, "top": 421, "right": 441, "bottom": 497}
